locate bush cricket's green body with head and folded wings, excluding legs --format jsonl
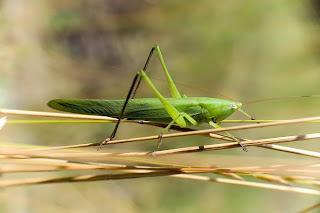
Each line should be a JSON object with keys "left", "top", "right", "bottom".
{"left": 48, "top": 97, "right": 242, "bottom": 125}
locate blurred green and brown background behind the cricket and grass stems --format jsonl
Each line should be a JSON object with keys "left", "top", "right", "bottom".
{"left": 0, "top": 0, "right": 320, "bottom": 213}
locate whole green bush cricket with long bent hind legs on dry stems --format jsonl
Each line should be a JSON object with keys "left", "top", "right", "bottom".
{"left": 48, "top": 45, "right": 254, "bottom": 151}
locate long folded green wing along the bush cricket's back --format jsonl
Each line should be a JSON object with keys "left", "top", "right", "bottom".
{"left": 48, "top": 98, "right": 204, "bottom": 123}
